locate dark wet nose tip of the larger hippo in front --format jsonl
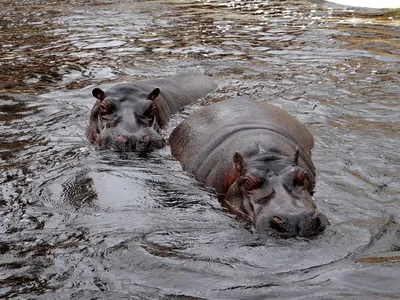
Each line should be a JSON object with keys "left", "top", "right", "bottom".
{"left": 258, "top": 210, "right": 329, "bottom": 238}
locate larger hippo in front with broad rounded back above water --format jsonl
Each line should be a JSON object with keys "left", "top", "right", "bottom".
{"left": 170, "top": 98, "right": 329, "bottom": 237}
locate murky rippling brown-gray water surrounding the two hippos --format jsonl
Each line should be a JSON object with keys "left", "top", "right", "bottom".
{"left": 0, "top": 0, "right": 400, "bottom": 299}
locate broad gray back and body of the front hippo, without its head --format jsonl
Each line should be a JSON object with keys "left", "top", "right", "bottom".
{"left": 170, "top": 97, "right": 315, "bottom": 193}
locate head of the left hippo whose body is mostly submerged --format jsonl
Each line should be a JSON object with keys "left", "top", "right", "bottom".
{"left": 86, "top": 84, "right": 166, "bottom": 152}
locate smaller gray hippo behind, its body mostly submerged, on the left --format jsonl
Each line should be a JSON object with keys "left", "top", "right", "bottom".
{"left": 86, "top": 74, "right": 217, "bottom": 152}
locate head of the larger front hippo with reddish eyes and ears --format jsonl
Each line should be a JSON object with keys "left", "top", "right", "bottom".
{"left": 224, "top": 150, "right": 329, "bottom": 238}
